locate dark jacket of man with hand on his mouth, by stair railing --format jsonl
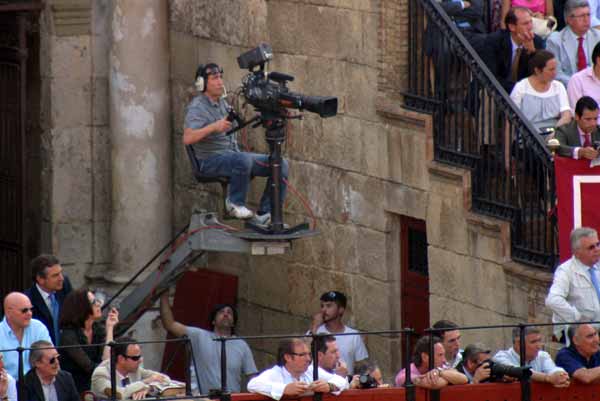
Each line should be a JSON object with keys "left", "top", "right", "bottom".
{"left": 481, "top": 29, "right": 544, "bottom": 95}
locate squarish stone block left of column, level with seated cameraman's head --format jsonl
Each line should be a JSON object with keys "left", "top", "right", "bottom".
{"left": 51, "top": 76, "right": 92, "bottom": 129}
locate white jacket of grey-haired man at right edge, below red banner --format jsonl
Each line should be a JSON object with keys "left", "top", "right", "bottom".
{"left": 546, "top": 256, "right": 600, "bottom": 336}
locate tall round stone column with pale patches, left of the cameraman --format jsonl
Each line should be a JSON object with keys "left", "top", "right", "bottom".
{"left": 105, "top": 0, "right": 172, "bottom": 282}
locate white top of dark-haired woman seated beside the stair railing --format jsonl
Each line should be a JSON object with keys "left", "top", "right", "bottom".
{"left": 510, "top": 78, "right": 571, "bottom": 129}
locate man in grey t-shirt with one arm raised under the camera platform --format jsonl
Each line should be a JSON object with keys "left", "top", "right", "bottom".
{"left": 160, "top": 292, "right": 257, "bottom": 394}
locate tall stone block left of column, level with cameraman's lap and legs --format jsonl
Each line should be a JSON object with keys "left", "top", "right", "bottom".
{"left": 51, "top": 127, "right": 93, "bottom": 223}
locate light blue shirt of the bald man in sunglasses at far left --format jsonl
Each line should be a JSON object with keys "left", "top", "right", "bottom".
{"left": 0, "top": 317, "right": 52, "bottom": 378}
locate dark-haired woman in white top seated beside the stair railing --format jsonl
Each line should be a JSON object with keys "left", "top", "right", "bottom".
{"left": 510, "top": 50, "right": 572, "bottom": 132}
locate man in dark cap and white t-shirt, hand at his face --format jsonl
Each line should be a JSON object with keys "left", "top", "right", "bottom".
{"left": 310, "top": 291, "right": 369, "bottom": 375}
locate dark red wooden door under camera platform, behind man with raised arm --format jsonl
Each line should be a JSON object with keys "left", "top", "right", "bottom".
{"left": 162, "top": 270, "right": 238, "bottom": 381}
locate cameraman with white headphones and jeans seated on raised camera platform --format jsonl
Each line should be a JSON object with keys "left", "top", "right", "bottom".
{"left": 183, "top": 63, "right": 288, "bottom": 225}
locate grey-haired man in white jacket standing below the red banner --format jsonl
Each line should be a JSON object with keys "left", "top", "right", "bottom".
{"left": 546, "top": 227, "right": 600, "bottom": 342}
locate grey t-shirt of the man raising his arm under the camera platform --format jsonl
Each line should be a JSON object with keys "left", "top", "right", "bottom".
{"left": 186, "top": 326, "right": 257, "bottom": 394}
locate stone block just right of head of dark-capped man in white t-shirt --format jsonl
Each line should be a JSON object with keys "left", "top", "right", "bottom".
{"left": 346, "top": 275, "right": 391, "bottom": 330}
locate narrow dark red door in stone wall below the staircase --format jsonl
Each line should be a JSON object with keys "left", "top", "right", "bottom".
{"left": 400, "top": 216, "right": 429, "bottom": 356}
